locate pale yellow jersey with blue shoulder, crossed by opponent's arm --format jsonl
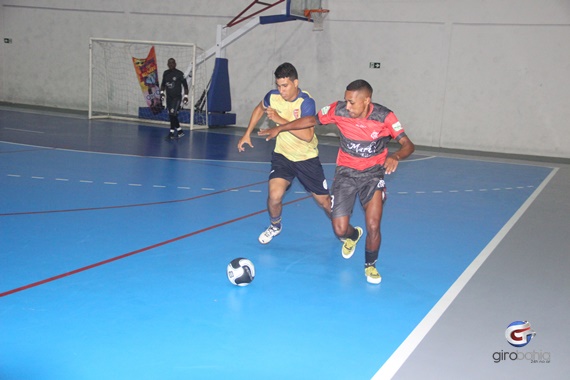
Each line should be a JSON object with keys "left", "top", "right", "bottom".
{"left": 263, "top": 89, "right": 319, "bottom": 162}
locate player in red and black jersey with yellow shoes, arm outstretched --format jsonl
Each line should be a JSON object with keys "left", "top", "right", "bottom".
{"left": 259, "top": 79, "right": 415, "bottom": 284}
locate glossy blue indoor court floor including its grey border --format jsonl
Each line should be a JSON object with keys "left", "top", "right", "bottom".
{"left": 0, "top": 106, "right": 570, "bottom": 380}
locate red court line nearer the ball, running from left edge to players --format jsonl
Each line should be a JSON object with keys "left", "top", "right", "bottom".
{"left": 0, "top": 195, "right": 312, "bottom": 298}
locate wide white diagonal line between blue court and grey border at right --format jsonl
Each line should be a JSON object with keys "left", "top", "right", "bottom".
{"left": 371, "top": 168, "right": 558, "bottom": 380}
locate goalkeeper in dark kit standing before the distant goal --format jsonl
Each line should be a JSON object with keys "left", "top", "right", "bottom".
{"left": 160, "top": 58, "right": 188, "bottom": 140}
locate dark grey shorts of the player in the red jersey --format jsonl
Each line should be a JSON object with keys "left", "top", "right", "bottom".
{"left": 332, "top": 165, "right": 386, "bottom": 218}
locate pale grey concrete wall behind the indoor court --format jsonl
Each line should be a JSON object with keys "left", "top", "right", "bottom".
{"left": 0, "top": 0, "right": 570, "bottom": 158}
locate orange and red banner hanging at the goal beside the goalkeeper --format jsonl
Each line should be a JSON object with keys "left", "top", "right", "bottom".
{"left": 132, "top": 46, "right": 163, "bottom": 115}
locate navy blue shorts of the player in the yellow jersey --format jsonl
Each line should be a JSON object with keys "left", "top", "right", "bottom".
{"left": 269, "top": 152, "right": 329, "bottom": 195}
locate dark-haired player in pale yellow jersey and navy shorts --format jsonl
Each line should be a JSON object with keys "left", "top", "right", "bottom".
{"left": 237, "top": 62, "right": 331, "bottom": 244}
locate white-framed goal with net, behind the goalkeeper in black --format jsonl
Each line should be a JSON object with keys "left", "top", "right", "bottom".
{"left": 89, "top": 38, "right": 208, "bottom": 129}
